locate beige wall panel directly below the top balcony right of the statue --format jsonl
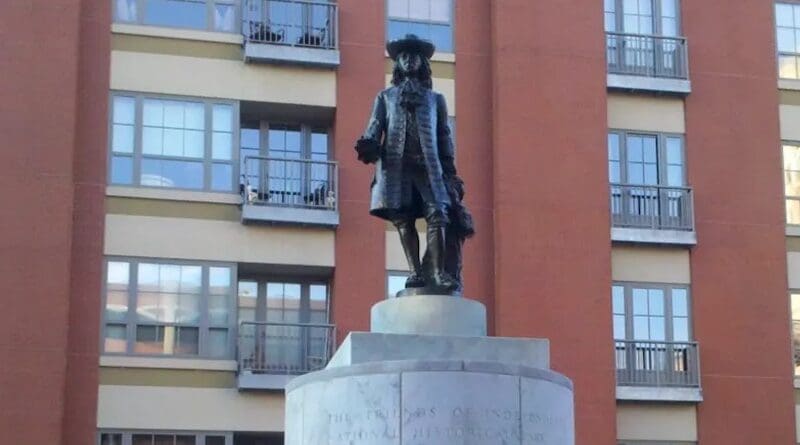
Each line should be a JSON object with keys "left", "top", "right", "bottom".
{"left": 608, "top": 93, "right": 686, "bottom": 133}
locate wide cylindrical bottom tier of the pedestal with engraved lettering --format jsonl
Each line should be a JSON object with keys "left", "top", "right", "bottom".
{"left": 285, "top": 360, "right": 575, "bottom": 445}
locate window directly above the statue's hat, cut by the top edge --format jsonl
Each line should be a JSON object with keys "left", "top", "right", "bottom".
{"left": 387, "top": 0, "right": 454, "bottom": 53}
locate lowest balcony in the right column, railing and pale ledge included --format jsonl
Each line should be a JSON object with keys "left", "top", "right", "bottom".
{"left": 615, "top": 340, "right": 703, "bottom": 402}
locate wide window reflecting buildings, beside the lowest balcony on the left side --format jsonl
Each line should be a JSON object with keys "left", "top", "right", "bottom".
{"left": 103, "top": 259, "right": 235, "bottom": 358}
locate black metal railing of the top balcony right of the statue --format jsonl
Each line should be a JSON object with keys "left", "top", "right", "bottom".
{"left": 606, "top": 32, "right": 689, "bottom": 79}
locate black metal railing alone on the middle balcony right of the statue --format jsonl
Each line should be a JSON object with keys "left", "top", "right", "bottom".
{"left": 610, "top": 184, "right": 694, "bottom": 231}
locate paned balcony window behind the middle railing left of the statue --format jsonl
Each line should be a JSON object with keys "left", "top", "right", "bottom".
{"left": 240, "top": 121, "right": 336, "bottom": 209}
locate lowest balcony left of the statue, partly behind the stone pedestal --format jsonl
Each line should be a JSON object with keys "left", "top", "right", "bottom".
{"left": 237, "top": 322, "right": 336, "bottom": 390}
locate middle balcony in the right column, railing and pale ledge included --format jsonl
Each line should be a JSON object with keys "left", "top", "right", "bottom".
{"left": 610, "top": 184, "right": 697, "bottom": 246}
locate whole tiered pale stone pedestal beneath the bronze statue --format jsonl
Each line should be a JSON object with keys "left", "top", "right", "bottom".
{"left": 285, "top": 296, "right": 575, "bottom": 445}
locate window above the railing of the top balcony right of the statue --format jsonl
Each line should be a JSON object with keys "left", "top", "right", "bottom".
{"left": 604, "top": 0, "right": 680, "bottom": 37}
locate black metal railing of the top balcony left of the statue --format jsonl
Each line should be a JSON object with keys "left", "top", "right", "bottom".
{"left": 242, "top": 0, "right": 339, "bottom": 49}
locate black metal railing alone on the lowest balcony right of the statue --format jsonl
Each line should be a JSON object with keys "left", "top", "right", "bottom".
{"left": 615, "top": 340, "right": 700, "bottom": 387}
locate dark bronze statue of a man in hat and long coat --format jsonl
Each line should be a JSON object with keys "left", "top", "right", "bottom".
{"left": 356, "top": 34, "right": 474, "bottom": 295}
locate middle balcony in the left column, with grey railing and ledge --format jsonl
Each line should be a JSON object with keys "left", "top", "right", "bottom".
{"left": 241, "top": 156, "right": 339, "bottom": 227}
